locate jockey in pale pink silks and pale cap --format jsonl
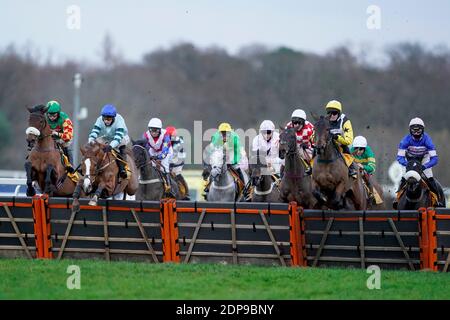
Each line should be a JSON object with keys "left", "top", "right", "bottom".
{"left": 252, "top": 120, "right": 283, "bottom": 176}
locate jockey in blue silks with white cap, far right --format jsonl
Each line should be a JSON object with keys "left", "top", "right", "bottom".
{"left": 397, "top": 118, "right": 445, "bottom": 206}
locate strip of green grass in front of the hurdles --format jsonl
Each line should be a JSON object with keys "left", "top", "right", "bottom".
{"left": 0, "top": 259, "right": 450, "bottom": 300}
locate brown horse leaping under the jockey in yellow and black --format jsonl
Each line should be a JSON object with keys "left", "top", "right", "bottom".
{"left": 312, "top": 116, "right": 367, "bottom": 210}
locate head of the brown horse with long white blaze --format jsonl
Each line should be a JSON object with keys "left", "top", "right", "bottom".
{"left": 80, "top": 142, "right": 106, "bottom": 194}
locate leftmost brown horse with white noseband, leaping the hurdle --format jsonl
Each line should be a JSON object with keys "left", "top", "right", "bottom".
{"left": 25, "top": 105, "right": 75, "bottom": 197}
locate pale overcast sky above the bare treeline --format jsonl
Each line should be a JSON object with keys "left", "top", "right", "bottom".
{"left": 0, "top": 0, "right": 450, "bottom": 63}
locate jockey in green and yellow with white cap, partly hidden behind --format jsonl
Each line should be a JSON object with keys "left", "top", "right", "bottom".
{"left": 350, "top": 136, "right": 376, "bottom": 198}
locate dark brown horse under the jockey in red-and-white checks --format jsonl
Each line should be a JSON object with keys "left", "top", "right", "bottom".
{"left": 279, "top": 128, "right": 317, "bottom": 209}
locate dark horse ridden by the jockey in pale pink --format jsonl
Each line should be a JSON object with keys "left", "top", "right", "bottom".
{"left": 249, "top": 150, "right": 280, "bottom": 202}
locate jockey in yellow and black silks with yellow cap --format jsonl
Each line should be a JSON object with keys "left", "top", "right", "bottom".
{"left": 325, "top": 100, "right": 357, "bottom": 178}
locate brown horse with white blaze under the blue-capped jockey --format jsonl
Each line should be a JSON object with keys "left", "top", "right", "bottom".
{"left": 72, "top": 139, "right": 139, "bottom": 211}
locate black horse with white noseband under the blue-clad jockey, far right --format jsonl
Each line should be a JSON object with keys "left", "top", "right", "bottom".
{"left": 395, "top": 159, "right": 435, "bottom": 210}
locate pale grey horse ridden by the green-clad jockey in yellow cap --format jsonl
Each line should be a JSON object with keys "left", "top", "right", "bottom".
{"left": 206, "top": 148, "right": 239, "bottom": 202}
